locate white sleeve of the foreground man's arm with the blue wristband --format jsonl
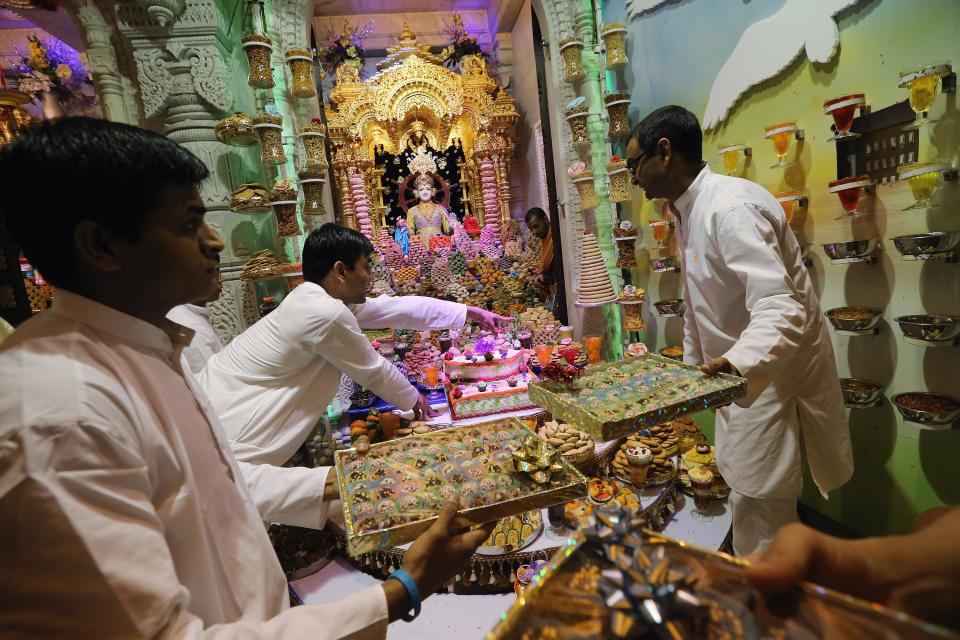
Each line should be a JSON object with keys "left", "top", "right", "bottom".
{"left": 0, "top": 423, "right": 388, "bottom": 639}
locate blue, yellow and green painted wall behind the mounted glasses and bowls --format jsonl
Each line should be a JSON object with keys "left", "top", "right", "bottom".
{"left": 606, "top": 0, "right": 960, "bottom": 534}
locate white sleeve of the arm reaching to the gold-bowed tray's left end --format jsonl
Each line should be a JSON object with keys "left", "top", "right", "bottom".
{"left": 237, "top": 460, "right": 330, "bottom": 529}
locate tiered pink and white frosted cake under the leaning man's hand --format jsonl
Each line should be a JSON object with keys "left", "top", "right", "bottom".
{"left": 443, "top": 349, "right": 537, "bottom": 420}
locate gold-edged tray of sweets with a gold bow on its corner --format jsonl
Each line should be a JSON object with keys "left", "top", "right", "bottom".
{"left": 334, "top": 419, "right": 587, "bottom": 556}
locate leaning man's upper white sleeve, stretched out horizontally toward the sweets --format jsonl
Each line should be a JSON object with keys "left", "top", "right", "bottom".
{"left": 350, "top": 296, "right": 467, "bottom": 331}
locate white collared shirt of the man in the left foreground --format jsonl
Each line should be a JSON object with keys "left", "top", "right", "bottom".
{"left": 0, "top": 289, "right": 387, "bottom": 639}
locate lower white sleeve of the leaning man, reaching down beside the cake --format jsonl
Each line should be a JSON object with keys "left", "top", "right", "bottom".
{"left": 314, "top": 309, "right": 420, "bottom": 411}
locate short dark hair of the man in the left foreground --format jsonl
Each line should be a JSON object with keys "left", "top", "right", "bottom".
{"left": 0, "top": 118, "right": 209, "bottom": 286}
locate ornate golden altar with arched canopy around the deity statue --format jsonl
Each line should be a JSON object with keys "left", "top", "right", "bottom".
{"left": 326, "top": 25, "right": 519, "bottom": 237}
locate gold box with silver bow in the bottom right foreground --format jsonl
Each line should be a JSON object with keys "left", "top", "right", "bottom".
{"left": 487, "top": 511, "right": 957, "bottom": 640}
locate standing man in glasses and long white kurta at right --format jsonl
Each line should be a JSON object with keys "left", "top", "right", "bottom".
{"left": 627, "top": 107, "right": 853, "bottom": 555}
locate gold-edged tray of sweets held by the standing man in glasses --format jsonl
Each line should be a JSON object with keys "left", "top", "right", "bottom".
{"left": 529, "top": 353, "right": 747, "bottom": 442}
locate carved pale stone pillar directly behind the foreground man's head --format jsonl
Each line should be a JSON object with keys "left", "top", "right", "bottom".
{"left": 115, "top": 0, "right": 257, "bottom": 340}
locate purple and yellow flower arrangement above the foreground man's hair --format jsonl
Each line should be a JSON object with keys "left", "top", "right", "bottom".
{"left": 13, "top": 35, "right": 96, "bottom": 108}
